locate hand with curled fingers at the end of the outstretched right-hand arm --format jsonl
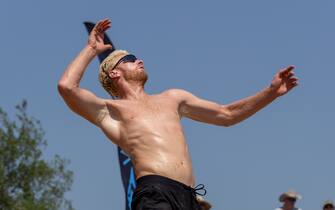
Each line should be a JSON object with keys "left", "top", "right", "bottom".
{"left": 271, "top": 66, "right": 298, "bottom": 96}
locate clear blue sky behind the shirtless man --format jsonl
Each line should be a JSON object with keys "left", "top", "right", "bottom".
{"left": 0, "top": 0, "right": 335, "bottom": 210}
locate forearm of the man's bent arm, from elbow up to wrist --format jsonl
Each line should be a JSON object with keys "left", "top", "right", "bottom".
{"left": 59, "top": 46, "right": 96, "bottom": 89}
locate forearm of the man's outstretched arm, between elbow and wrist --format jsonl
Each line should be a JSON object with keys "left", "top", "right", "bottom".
{"left": 225, "top": 87, "right": 278, "bottom": 124}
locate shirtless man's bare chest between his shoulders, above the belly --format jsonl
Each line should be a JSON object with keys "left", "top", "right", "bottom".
{"left": 103, "top": 94, "right": 182, "bottom": 144}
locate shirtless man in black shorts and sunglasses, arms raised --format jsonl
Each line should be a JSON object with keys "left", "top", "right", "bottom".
{"left": 58, "top": 19, "right": 298, "bottom": 210}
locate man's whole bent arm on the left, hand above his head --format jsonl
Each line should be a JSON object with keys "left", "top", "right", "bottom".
{"left": 58, "top": 19, "right": 112, "bottom": 126}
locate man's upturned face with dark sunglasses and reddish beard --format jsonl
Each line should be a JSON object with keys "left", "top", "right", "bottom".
{"left": 114, "top": 55, "right": 148, "bottom": 85}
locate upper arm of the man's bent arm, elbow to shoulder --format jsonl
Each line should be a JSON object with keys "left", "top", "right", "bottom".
{"left": 59, "top": 87, "right": 107, "bottom": 125}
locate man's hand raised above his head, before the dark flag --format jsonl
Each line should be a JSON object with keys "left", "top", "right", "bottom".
{"left": 87, "top": 19, "right": 112, "bottom": 54}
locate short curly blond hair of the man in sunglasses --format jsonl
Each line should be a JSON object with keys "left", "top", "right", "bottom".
{"left": 99, "top": 50, "right": 129, "bottom": 96}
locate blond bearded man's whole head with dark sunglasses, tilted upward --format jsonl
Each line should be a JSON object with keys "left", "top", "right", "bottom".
{"left": 99, "top": 50, "right": 148, "bottom": 96}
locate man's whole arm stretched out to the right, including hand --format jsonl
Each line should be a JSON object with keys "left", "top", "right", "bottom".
{"left": 178, "top": 66, "right": 298, "bottom": 126}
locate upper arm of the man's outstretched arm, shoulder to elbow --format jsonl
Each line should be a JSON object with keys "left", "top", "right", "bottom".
{"left": 180, "top": 92, "right": 230, "bottom": 126}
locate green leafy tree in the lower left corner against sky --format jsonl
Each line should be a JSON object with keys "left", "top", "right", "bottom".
{"left": 0, "top": 101, "right": 73, "bottom": 210}
